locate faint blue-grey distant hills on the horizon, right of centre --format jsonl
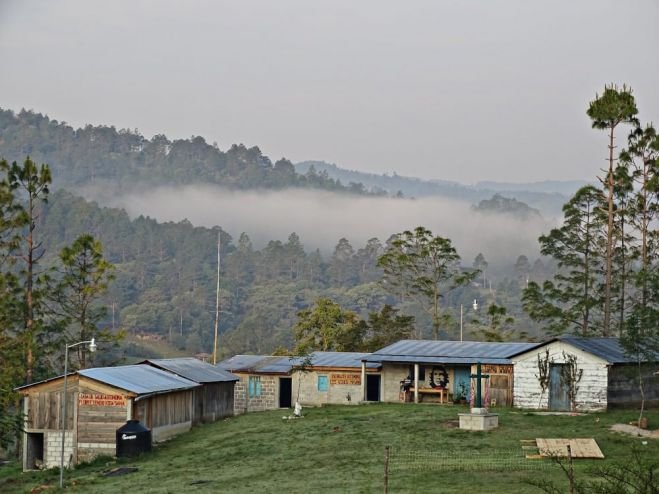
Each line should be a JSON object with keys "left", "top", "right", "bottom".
{"left": 295, "top": 161, "right": 585, "bottom": 216}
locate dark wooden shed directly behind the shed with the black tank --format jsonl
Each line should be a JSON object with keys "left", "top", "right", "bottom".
{"left": 142, "top": 357, "right": 240, "bottom": 424}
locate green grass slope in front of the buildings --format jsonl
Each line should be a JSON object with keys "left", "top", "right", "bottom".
{"left": 0, "top": 404, "right": 659, "bottom": 494}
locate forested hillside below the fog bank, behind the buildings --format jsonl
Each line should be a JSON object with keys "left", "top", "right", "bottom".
{"left": 34, "top": 190, "right": 551, "bottom": 354}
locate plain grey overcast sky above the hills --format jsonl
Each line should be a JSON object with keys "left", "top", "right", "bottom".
{"left": 0, "top": 0, "right": 659, "bottom": 183}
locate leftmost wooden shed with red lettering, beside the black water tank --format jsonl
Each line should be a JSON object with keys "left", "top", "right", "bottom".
{"left": 17, "top": 365, "right": 200, "bottom": 470}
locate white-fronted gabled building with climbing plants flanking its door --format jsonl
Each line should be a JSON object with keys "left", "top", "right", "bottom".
{"left": 511, "top": 336, "right": 659, "bottom": 411}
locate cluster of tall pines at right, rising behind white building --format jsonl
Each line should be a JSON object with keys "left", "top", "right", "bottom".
{"left": 523, "top": 85, "right": 659, "bottom": 348}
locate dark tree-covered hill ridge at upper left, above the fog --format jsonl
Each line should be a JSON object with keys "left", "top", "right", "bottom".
{"left": 0, "top": 109, "right": 374, "bottom": 195}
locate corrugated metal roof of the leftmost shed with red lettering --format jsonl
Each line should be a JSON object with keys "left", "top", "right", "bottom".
{"left": 78, "top": 365, "right": 200, "bottom": 395}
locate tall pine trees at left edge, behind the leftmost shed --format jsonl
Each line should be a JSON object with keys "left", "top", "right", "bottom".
{"left": 0, "top": 158, "right": 117, "bottom": 452}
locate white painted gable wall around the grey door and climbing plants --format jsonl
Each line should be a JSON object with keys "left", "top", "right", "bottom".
{"left": 513, "top": 341, "right": 608, "bottom": 411}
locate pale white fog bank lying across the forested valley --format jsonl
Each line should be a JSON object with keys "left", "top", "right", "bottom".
{"left": 100, "top": 186, "right": 549, "bottom": 263}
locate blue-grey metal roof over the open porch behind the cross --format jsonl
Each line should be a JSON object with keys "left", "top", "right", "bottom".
{"left": 364, "top": 340, "right": 536, "bottom": 364}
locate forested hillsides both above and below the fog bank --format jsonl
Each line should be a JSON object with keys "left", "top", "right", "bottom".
{"left": 0, "top": 110, "right": 553, "bottom": 362}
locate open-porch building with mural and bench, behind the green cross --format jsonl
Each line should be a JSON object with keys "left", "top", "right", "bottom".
{"left": 362, "top": 340, "right": 534, "bottom": 406}
